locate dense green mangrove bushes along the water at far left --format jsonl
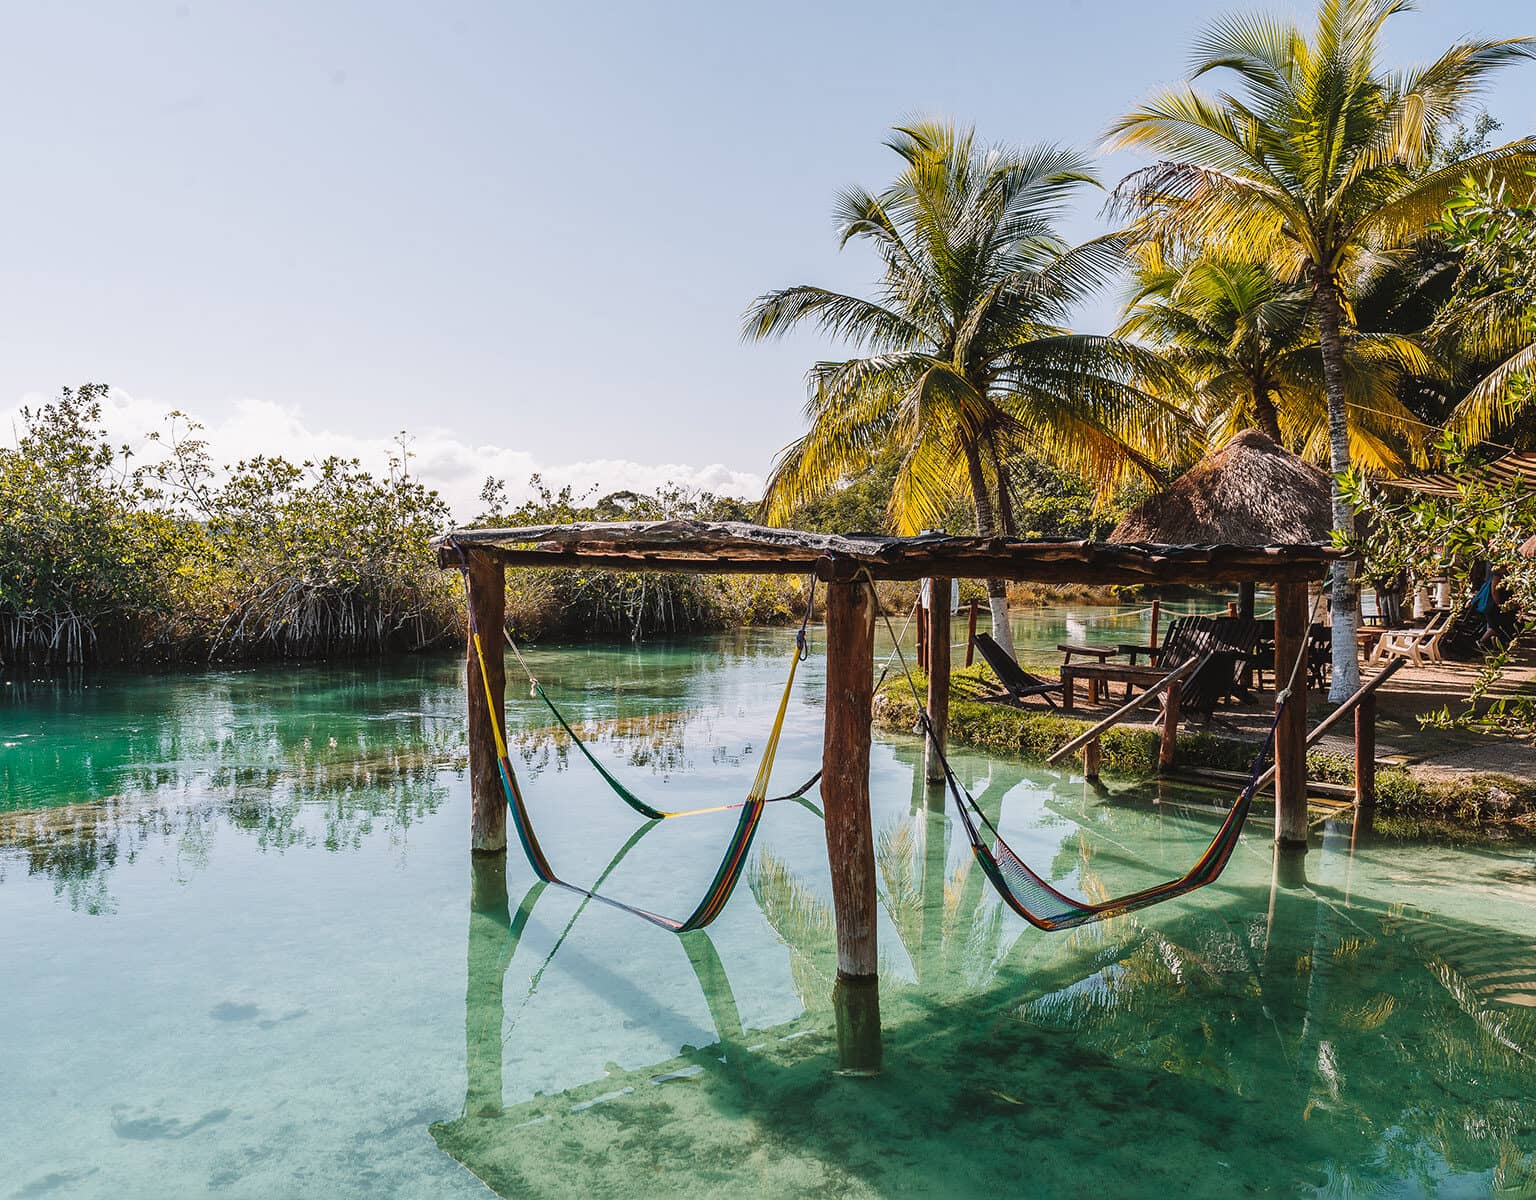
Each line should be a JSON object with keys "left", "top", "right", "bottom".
{"left": 0, "top": 384, "right": 458, "bottom": 662}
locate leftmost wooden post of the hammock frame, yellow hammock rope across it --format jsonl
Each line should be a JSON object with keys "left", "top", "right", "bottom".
{"left": 464, "top": 553, "right": 507, "bottom": 853}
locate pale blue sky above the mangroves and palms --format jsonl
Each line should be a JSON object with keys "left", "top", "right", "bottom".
{"left": 0, "top": 0, "right": 1536, "bottom": 510}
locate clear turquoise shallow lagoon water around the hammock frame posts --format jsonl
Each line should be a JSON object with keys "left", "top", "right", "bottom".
{"left": 0, "top": 617, "right": 1536, "bottom": 1197}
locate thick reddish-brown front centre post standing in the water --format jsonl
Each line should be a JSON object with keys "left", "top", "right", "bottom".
{"left": 822, "top": 564, "right": 880, "bottom": 1076}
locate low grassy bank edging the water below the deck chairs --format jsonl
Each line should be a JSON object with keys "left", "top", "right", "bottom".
{"left": 874, "top": 667, "right": 1536, "bottom": 830}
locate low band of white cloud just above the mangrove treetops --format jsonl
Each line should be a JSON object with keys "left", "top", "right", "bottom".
{"left": 0, "top": 389, "right": 763, "bottom": 519}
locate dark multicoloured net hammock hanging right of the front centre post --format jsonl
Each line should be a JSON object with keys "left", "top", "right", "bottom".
{"left": 865, "top": 572, "right": 1316, "bottom": 933}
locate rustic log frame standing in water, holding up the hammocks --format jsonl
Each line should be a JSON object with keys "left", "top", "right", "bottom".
{"left": 438, "top": 521, "right": 1338, "bottom": 1074}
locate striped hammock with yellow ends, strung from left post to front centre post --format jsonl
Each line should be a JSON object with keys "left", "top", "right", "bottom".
{"left": 455, "top": 547, "right": 814, "bottom": 933}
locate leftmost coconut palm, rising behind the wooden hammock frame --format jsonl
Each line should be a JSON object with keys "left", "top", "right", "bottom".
{"left": 743, "top": 123, "right": 1187, "bottom": 651}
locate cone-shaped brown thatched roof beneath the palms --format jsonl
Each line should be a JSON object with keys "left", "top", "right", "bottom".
{"left": 1109, "top": 429, "right": 1333, "bottom": 545}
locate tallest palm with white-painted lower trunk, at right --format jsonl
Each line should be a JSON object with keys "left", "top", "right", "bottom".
{"left": 1109, "top": 0, "right": 1536, "bottom": 701}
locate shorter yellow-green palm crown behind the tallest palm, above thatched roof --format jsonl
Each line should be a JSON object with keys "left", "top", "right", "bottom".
{"left": 1117, "top": 244, "right": 1430, "bottom": 470}
